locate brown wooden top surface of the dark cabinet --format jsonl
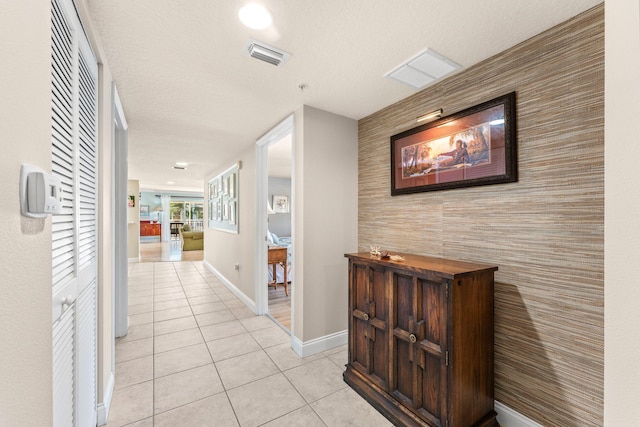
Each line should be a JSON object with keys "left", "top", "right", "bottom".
{"left": 344, "top": 252, "right": 498, "bottom": 277}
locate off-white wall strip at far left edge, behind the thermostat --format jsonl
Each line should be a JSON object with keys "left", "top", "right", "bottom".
{"left": 0, "top": 0, "right": 52, "bottom": 426}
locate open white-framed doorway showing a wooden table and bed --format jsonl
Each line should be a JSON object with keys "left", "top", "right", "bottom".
{"left": 255, "top": 115, "right": 295, "bottom": 334}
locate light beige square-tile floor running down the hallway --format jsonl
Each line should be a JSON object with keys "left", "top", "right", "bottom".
{"left": 107, "top": 261, "right": 391, "bottom": 427}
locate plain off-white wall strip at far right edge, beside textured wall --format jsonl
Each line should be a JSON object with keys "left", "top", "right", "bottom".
{"left": 604, "top": 0, "right": 640, "bottom": 426}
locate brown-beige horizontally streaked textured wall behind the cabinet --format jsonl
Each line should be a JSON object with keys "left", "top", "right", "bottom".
{"left": 358, "top": 4, "right": 604, "bottom": 426}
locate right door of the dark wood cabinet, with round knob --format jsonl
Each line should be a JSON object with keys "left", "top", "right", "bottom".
{"left": 388, "top": 270, "right": 448, "bottom": 425}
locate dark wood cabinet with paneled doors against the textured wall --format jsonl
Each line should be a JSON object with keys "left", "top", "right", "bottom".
{"left": 344, "top": 253, "right": 498, "bottom": 427}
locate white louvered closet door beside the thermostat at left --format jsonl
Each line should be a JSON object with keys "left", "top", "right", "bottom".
{"left": 51, "top": 0, "right": 98, "bottom": 427}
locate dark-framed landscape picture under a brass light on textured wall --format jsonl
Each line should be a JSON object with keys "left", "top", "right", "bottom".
{"left": 388, "top": 92, "right": 518, "bottom": 196}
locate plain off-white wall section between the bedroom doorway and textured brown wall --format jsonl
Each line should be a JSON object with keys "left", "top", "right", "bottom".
{"left": 293, "top": 106, "right": 358, "bottom": 343}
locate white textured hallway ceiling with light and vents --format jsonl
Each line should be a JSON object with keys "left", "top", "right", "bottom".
{"left": 86, "top": 0, "right": 601, "bottom": 191}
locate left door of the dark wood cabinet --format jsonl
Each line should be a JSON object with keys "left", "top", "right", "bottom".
{"left": 349, "top": 263, "right": 389, "bottom": 390}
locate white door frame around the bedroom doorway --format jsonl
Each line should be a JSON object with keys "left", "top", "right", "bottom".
{"left": 254, "top": 114, "right": 296, "bottom": 328}
